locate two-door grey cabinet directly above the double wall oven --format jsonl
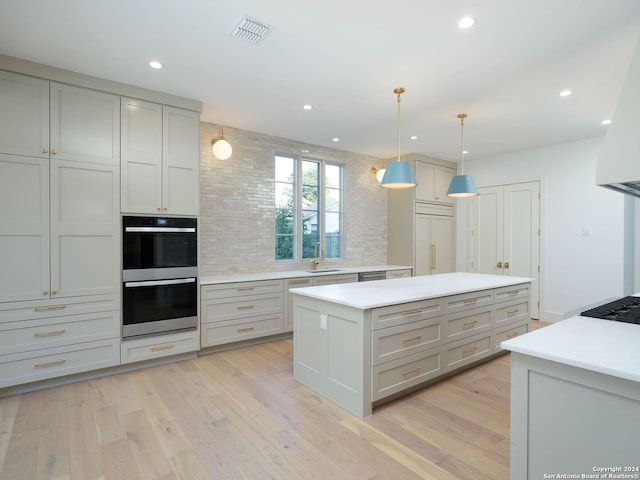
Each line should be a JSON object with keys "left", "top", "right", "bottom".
{"left": 121, "top": 98, "right": 200, "bottom": 215}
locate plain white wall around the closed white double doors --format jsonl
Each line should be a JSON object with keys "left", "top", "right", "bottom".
{"left": 457, "top": 137, "right": 624, "bottom": 321}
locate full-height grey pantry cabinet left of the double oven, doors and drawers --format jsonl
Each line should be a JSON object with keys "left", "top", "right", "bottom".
{"left": 0, "top": 71, "right": 120, "bottom": 388}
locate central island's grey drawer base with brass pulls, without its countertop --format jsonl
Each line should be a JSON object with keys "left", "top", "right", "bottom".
{"left": 293, "top": 283, "right": 530, "bottom": 417}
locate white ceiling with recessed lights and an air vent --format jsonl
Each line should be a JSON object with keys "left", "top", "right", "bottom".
{"left": 0, "top": 0, "right": 640, "bottom": 161}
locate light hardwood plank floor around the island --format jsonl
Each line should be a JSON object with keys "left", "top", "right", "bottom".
{"left": 0, "top": 322, "right": 548, "bottom": 480}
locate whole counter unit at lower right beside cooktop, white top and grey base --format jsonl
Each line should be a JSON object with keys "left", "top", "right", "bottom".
{"left": 502, "top": 316, "right": 640, "bottom": 479}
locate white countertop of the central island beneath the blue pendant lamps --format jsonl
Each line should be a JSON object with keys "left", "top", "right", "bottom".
{"left": 289, "top": 272, "right": 532, "bottom": 310}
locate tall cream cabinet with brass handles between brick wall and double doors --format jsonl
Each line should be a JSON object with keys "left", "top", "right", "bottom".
{"left": 387, "top": 154, "right": 456, "bottom": 275}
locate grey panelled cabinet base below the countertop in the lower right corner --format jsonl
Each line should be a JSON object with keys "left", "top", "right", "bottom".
{"left": 510, "top": 352, "right": 640, "bottom": 479}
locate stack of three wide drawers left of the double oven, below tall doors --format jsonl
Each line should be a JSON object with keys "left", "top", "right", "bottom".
{"left": 0, "top": 295, "right": 120, "bottom": 388}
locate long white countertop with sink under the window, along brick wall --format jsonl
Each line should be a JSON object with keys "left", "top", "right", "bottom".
{"left": 200, "top": 265, "right": 412, "bottom": 285}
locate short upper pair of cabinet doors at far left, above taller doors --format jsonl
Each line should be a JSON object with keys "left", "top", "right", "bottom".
{"left": 0, "top": 71, "right": 120, "bottom": 165}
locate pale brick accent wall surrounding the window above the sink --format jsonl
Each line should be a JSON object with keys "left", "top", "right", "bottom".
{"left": 199, "top": 122, "right": 387, "bottom": 276}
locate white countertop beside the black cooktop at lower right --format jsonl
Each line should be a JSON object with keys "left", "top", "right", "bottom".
{"left": 500, "top": 316, "right": 640, "bottom": 382}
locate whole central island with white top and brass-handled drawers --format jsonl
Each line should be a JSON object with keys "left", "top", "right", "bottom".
{"left": 290, "top": 273, "right": 531, "bottom": 417}
